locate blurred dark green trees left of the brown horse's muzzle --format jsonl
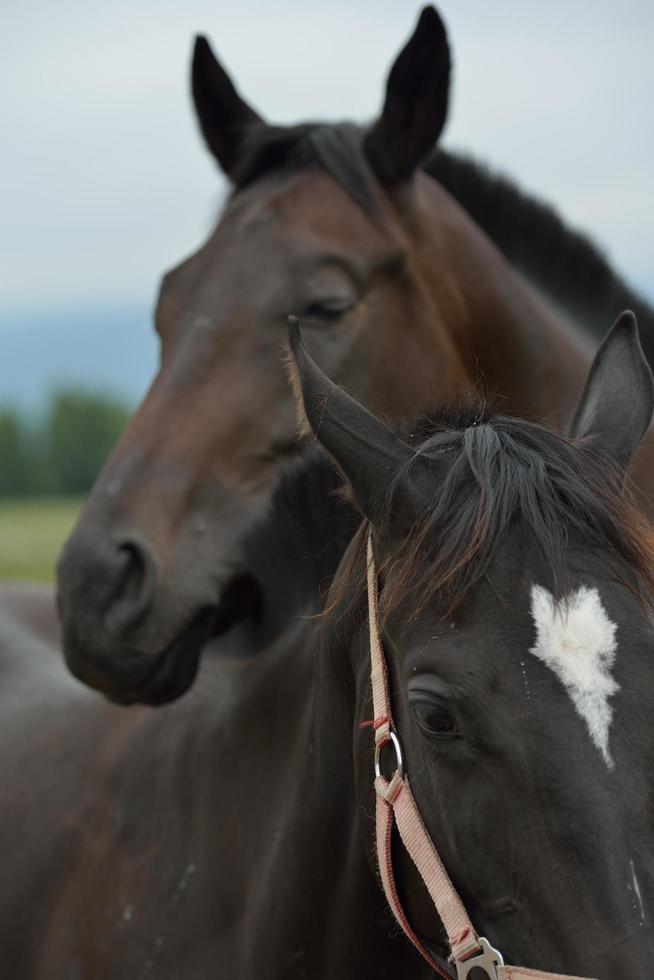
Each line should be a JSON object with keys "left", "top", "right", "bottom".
{"left": 0, "top": 388, "right": 132, "bottom": 497}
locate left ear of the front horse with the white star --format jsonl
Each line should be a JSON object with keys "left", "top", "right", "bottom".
{"left": 288, "top": 317, "right": 414, "bottom": 525}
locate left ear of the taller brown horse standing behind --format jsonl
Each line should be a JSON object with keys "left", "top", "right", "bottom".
{"left": 191, "top": 35, "right": 262, "bottom": 177}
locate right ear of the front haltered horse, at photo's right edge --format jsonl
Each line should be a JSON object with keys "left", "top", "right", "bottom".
{"left": 570, "top": 311, "right": 654, "bottom": 471}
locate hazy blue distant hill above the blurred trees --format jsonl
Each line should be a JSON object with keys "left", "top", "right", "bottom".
{"left": 0, "top": 306, "right": 158, "bottom": 412}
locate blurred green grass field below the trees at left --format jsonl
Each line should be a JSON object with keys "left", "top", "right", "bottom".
{"left": 0, "top": 498, "right": 82, "bottom": 582}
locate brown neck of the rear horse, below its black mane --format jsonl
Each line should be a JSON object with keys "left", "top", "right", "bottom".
{"left": 414, "top": 174, "right": 592, "bottom": 422}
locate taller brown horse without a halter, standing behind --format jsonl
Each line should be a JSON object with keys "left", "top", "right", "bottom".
{"left": 59, "top": 8, "right": 651, "bottom": 704}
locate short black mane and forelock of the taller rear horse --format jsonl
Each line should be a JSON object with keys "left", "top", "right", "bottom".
{"left": 234, "top": 122, "right": 654, "bottom": 364}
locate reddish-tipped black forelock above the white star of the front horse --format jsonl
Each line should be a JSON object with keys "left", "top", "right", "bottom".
{"left": 340, "top": 405, "right": 654, "bottom": 620}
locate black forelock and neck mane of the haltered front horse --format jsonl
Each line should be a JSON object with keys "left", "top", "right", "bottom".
{"left": 245, "top": 404, "right": 654, "bottom": 633}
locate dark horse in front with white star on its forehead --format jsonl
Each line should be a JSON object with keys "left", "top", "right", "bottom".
{"left": 5, "top": 319, "right": 654, "bottom": 980}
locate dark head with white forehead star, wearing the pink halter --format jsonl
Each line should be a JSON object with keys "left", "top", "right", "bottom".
{"left": 293, "top": 314, "right": 654, "bottom": 980}
